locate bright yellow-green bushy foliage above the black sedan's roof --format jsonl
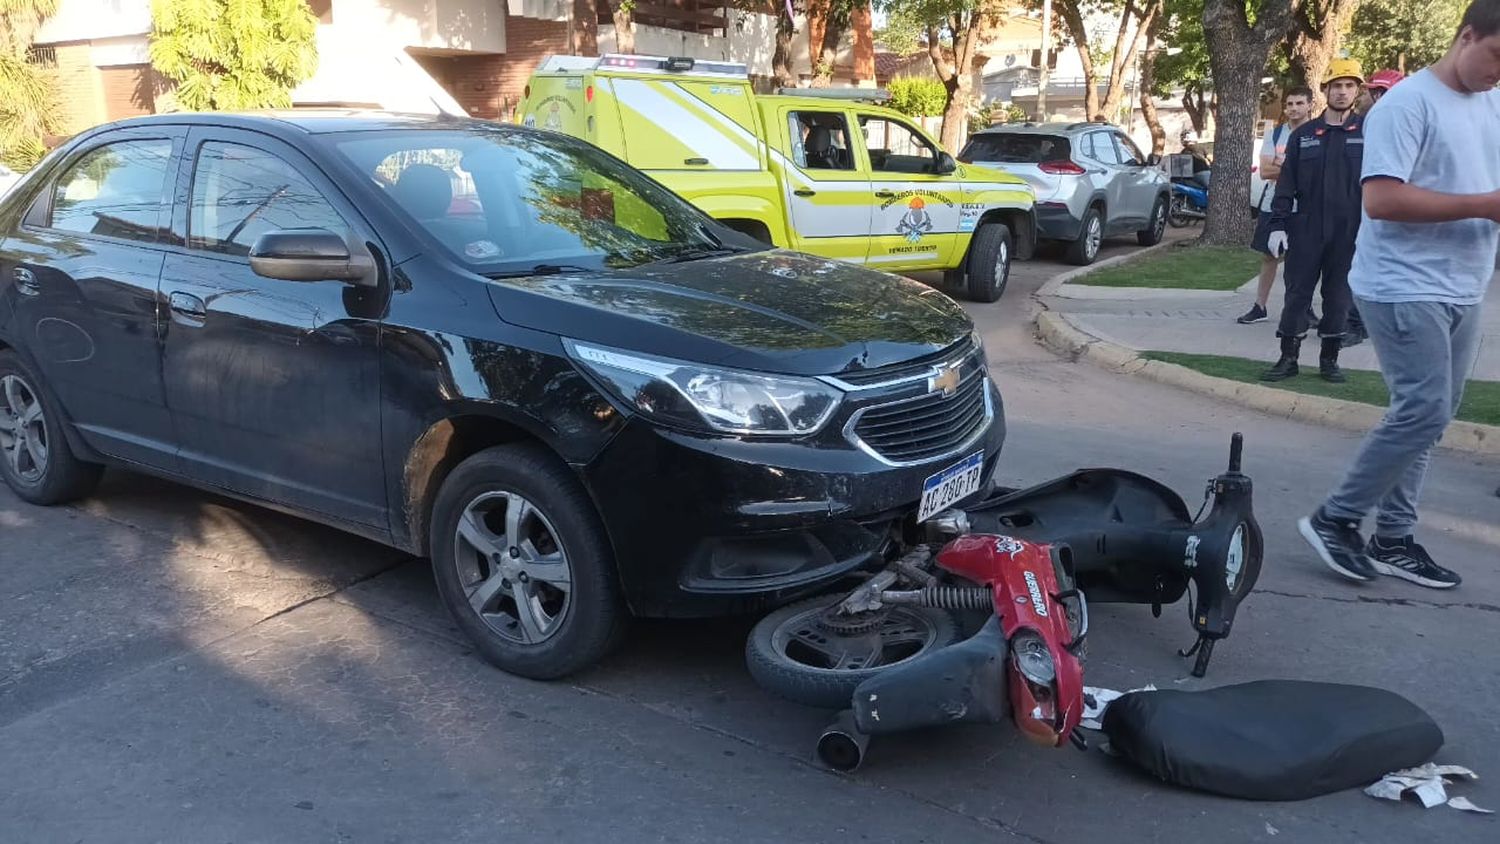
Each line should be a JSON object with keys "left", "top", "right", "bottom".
{"left": 150, "top": 0, "right": 318, "bottom": 111}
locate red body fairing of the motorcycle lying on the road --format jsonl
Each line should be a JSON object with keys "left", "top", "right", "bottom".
{"left": 938, "top": 534, "right": 1086, "bottom": 747}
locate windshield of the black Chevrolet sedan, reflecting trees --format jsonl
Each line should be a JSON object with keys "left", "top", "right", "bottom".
{"left": 335, "top": 127, "right": 741, "bottom": 274}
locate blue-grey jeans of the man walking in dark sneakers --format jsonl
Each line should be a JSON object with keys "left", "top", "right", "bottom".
{"left": 1323, "top": 298, "right": 1481, "bottom": 540}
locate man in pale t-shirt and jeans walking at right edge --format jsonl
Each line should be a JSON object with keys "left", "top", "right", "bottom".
{"left": 1298, "top": 0, "right": 1500, "bottom": 589}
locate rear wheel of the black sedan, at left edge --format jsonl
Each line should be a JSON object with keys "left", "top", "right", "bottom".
{"left": 0, "top": 351, "right": 104, "bottom": 507}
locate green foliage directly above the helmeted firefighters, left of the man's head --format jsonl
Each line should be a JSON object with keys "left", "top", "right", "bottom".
{"left": 1344, "top": 0, "right": 1467, "bottom": 73}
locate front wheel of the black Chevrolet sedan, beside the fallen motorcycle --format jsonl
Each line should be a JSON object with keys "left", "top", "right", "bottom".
{"left": 429, "top": 445, "right": 629, "bottom": 679}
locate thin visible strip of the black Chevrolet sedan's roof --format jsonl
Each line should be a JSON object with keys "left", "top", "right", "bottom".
{"left": 80, "top": 108, "right": 492, "bottom": 135}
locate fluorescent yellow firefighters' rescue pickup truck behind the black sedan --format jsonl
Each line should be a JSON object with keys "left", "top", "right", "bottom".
{"left": 518, "top": 55, "right": 1037, "bottom": 301}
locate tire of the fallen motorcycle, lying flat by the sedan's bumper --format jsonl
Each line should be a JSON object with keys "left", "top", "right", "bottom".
{"left": 746, "top": 595, "right": 960, "bottom": 709}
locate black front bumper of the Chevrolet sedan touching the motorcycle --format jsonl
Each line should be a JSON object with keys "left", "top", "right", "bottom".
{"left": 579, "top": 384, "right": 1005, "bottom": 618}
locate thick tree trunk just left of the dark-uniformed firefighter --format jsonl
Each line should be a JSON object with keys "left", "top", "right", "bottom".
{"left": 1203, "top": 0, "right": 1293, "bottom": 246}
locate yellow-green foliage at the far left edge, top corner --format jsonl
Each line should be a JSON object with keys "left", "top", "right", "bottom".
{"left": 0, "top": 0, "right": 62, "bottom": 169}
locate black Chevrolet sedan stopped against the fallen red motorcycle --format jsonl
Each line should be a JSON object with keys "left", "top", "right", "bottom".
{"left": 0, "top": 112, "right": 1005, "bottom": 678}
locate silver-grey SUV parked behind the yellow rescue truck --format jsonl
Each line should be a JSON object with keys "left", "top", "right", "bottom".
{"left": 959, "top": 123, "right": 1172, "bottom": 265}
